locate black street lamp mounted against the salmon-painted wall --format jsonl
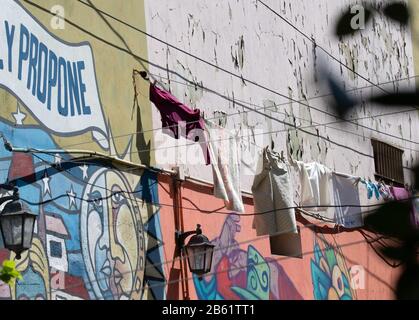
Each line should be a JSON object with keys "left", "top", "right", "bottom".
{"left": 175, "top": 224, "right": 215, "bottom": 279}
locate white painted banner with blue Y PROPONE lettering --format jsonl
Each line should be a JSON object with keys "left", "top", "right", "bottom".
{"left": 0, "top": 0, "right": 109, "bottom": 149}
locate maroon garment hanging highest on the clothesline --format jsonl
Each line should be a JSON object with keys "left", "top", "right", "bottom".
{"left": 150, "top": 84, "right": 211, "bottom": 165}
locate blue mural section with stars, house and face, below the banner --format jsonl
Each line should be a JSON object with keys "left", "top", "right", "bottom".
{"left": 0, "top": 107, "right": 164, "bottom": 299}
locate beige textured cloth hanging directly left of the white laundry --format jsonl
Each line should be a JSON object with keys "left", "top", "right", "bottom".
{"left": 252, "top": 147, "right": 298, "bottom": 236}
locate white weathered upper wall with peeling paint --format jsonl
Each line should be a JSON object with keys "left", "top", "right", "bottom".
{"left": 146, "top": 0, "right": 419, "bottom": 190}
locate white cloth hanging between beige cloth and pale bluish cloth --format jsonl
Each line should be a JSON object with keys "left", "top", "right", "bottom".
{"left": 296, "top": 161, "right": 334, "bottom": 222}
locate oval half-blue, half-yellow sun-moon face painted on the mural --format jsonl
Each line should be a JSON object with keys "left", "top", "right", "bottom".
{"left": 80, "top": 169, "right": 145, "bottom": 299}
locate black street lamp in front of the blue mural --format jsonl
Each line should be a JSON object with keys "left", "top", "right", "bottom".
{"left": 0, "top": 185, "right": 37, "bottom": 259}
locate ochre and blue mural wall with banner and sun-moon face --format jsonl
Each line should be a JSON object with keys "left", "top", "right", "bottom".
{"left": 0, "top": 0, "right": 165, "bottom": 300}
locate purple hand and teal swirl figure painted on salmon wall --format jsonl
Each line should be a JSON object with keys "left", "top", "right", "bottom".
{"left": 194, "top": 214, "right": 302, "bottom": 300}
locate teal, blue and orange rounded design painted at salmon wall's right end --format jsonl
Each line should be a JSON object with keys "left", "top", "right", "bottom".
{"left": 310, "top": 235, "right": 356, "bottom": 300}
